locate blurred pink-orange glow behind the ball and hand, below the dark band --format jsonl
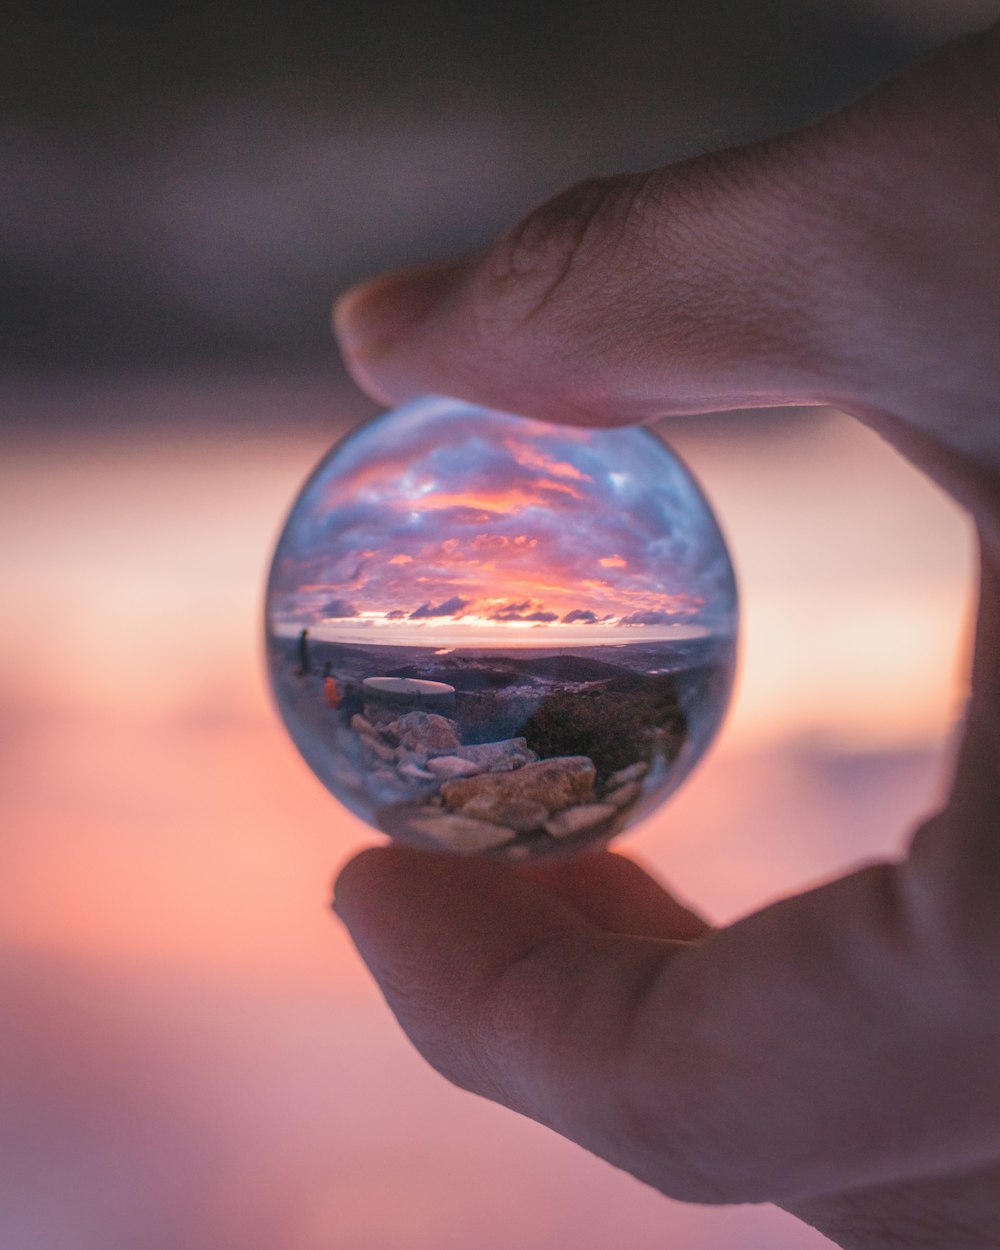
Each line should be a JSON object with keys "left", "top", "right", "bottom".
{"left": 0, "top": 380, "right": 971, "bottom": 1250}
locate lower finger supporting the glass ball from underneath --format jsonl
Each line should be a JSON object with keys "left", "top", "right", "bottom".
{"left": 336, "top": 846, "right": 1000, "bottom": 1203}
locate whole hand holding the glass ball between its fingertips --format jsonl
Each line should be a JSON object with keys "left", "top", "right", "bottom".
{"left": 336, "top": 28, "right": 1000, "bottom": 1250}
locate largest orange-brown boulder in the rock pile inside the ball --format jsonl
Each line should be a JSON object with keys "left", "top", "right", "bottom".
{"left": 441, "top": 755, "right": 596, "bottom": 833}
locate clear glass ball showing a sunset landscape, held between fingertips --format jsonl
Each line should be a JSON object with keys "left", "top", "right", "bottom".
{"left": 266, "top": 398, "right": 738, "bottom": 859}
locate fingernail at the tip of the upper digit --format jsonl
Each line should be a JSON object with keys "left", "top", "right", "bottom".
{"left": 334, "top": 264, "right": 463, "bottom": 359}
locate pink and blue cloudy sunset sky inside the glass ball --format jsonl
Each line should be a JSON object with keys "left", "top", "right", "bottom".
{"left": 270, "top": 400, "right": 735, "bottom": 645}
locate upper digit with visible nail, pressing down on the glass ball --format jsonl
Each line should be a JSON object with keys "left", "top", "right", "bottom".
{"left": 335, "top": 26, "right": 1000, "bottom": 430}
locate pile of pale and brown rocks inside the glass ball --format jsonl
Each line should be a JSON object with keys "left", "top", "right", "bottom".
{"left": 350, "top": 710, "right": 649, "bottom": 854}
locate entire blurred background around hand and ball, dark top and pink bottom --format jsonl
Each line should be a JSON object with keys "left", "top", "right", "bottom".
{"left": 0, "top": 0, "right": 1000, "bottom": 1250}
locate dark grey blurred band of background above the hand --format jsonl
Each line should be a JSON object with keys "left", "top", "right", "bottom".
{"left": 0, "top": 0, "right": 990, "bottom": 385}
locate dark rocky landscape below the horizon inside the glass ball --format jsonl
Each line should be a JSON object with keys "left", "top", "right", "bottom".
{"left": 270, "top": 636, "right": 731, "bottom": 859}
